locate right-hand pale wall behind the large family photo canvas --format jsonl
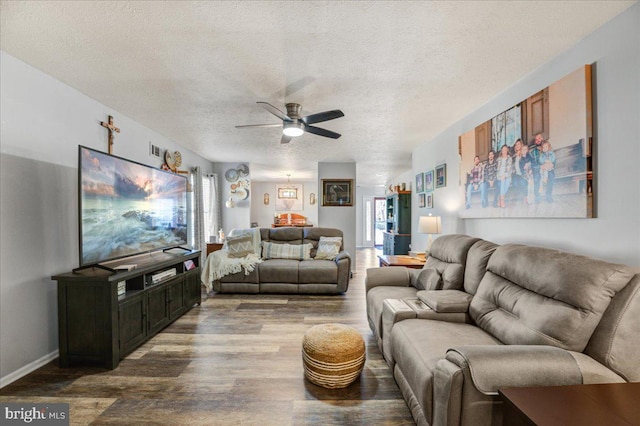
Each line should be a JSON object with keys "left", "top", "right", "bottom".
{"left": 412, "top": 4, "right": 640, "bottom": 267}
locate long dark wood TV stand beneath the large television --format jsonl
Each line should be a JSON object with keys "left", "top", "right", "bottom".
{"left": 52, "top": 249, "right": 201, "bottom": 369}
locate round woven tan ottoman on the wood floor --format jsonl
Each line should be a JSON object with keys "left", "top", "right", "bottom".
{"left": 302, "top": 324, "right": 365, "bottom": 389}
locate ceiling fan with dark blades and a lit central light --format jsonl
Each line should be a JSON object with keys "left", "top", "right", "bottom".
{"left": 236, "top": 102, "right": 344, "bottom": 143}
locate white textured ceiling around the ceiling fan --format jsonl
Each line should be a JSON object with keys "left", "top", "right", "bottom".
{"left": 0, "top": 1, "right": 634, "bottom": 185}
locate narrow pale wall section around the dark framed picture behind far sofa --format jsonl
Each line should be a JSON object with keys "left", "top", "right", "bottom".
{"left": 317, "top": 163, "right": 357, "bottom": 270}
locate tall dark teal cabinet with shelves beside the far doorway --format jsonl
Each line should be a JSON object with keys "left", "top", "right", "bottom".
{"left": 382, "top": 191, "right": 411, "bottom": 255}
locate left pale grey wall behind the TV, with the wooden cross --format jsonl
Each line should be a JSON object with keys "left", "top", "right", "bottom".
{"left": 0, "top": 52, "right": 212, "bottom": 386}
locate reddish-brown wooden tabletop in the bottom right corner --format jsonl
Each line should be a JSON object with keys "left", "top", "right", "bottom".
{"left": 499, "top": 383, "right": 640, "bottom": 426}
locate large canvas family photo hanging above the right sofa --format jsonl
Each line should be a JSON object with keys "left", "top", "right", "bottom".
{"left": 459, "top": 65, "right": 595, "bottom": 218}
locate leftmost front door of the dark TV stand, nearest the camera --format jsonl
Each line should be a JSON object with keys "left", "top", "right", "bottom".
{"left": 118, "top": 293, "right": 147, "bottom": 358}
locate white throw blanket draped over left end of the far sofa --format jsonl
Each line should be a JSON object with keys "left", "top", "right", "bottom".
{"left": 200, "top": 228, "right": 262, "bottom": 292}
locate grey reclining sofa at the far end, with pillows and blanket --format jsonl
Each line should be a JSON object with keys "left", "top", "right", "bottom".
{"left": 213, "top": 227, "right": 351, "bottom": 294}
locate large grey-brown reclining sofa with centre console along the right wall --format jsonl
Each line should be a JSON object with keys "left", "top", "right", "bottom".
{"left": 366, "top": 235, "right": 640, "bottom": 425}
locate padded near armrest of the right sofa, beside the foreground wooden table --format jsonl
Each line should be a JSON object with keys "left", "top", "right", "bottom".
{"left": 436, "top": 345, "right": 582, "bottom": 395}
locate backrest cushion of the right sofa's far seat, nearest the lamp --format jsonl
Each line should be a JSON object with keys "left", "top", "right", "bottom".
{"left": 423, "top": 234, "right": 479, "bottom": 290}
